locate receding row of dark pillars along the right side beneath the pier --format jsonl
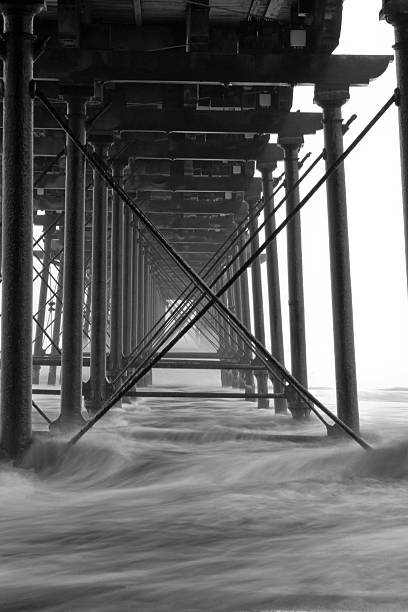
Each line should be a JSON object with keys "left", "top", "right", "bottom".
{"left": 222, "top": 101, "right": 359, "bottom": 432}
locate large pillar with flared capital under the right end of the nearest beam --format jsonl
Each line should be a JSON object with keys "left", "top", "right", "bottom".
{"left": 315, "top": 87, "right": 359, "bottom": 432}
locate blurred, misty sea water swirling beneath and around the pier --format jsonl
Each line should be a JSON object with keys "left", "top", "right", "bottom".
{"left": 0, "top": 372, "right": 408, "bottom": 612}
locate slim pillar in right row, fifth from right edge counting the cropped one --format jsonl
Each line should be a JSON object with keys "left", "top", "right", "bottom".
{"left": 249, "top": 208, "right": 269, "bottom": 408}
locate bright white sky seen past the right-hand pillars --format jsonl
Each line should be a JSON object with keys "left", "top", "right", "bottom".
{"left": 262, "top": 0, "right": 408, "bottom": 388}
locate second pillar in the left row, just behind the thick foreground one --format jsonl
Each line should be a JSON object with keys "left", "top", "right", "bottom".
{"left": 51, "top": 88, "right": 88, "bottom": 434}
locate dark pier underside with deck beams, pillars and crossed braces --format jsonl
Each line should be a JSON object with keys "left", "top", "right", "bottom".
{"left": 0, "top": 0, "right": 402, "bottom": 458}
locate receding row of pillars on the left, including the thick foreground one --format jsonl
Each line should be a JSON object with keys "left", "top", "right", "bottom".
{"left": 0, "top": 1, "right": 164, "bottom": 457}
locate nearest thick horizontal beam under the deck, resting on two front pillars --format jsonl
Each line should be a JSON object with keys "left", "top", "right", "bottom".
{"left": 35, "top": 48, "right": 392, "bottom": 87}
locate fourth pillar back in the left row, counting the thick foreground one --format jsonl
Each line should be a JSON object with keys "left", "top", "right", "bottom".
{"left": 109, "top": 162, "right": 123, "bottom": 374}
